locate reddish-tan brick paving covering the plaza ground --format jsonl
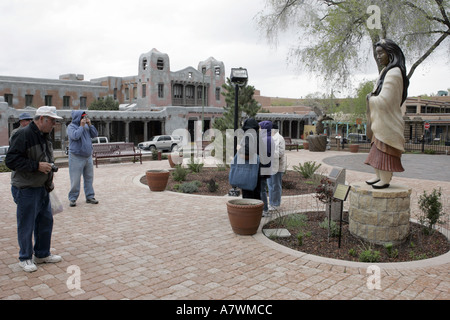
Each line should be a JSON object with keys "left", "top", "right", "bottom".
{"left": 0, "top": 150, "right": 450, "bottom": 300}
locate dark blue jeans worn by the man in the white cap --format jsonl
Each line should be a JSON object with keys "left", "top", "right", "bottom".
{"left": 11, "top": 186, "right": 53, "bottom": 261}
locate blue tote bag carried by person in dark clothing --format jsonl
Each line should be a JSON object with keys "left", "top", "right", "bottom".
{"left": 228, "top": 154, "right": 259, "bottom": 190}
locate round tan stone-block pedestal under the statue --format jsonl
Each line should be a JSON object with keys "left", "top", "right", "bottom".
{"left": 349, "top": 182, "right": 411, "bottom": 245}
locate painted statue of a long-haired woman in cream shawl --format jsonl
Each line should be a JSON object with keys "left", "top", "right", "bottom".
{"left": 365, "top": 39, "right": 409, "bottom": 189}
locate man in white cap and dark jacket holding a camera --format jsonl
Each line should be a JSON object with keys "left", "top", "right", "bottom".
{"left": 5, "top": 106, "right": 62, "bottom": 272}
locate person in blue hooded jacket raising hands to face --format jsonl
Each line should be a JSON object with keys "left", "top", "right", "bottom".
{"left": 67, "top": 110, "right": 98, "bottom": 207}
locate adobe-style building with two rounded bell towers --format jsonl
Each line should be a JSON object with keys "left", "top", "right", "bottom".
{"left": 0, "top": 49, "right": 314, "bottom": 149}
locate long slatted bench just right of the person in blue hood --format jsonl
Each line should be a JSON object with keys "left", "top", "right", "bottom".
{"left": 92, "top": 142, "right": 142, "bottom": 168}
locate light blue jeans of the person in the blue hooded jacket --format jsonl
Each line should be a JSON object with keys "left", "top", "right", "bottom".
{"left": 69, "top": 154, "right": 95, "bottom": 201}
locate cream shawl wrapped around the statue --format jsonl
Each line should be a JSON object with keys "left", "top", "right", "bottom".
{"left": 367, "top": 67, "right": 405, "bottom": 152}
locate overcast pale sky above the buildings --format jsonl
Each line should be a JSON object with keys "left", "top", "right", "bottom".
{"left": 0, "top": 0, "right": 450, "bottom": 98}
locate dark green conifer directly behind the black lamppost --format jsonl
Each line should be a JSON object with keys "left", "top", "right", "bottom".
{"left": 214, "top": 78, "right": 261, "bottom": 132}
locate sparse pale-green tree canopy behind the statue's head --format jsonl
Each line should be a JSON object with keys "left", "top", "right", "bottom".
{"left": 257, "top": 0, "right": 450, "bottom": 87}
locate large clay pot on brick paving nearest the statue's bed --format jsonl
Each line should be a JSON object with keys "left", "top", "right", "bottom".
{"left": 227, "top": 199, "right": 264, "bottom": 235}
